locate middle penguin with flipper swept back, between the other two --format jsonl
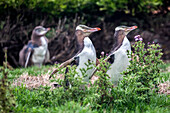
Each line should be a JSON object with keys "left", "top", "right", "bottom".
{"left": 50, "top": 25, "right": 101, "bottom": 82}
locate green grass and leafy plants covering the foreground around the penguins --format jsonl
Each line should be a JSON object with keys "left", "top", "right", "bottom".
{"left": 0, "top": 41, "right": 170, "bottom": 113}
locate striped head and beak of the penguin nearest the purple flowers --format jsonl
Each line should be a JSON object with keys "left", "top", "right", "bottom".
{"left": 115, "top": 26, "right": 138, "bottom": 35}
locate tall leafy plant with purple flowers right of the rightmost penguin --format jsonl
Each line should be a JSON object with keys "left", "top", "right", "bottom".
{"left": 121, "top": 35, "right": 163, "bottom": 100}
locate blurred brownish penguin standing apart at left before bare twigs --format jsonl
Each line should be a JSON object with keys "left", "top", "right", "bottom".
{"left": 19, "top": 26, "right": 50, "bottom": 67}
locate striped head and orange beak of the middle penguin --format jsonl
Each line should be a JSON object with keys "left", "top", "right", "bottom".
{"left": 76, "top": 25, "right": 101, "bottom": 37}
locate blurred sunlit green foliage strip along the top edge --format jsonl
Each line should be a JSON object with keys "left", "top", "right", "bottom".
{"left": 0, "top": 0, "right": 163, "bottom": 16}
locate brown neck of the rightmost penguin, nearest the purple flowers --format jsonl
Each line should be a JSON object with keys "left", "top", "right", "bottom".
{"left": 111, "top": 31, "right": 126, "bottom": 53}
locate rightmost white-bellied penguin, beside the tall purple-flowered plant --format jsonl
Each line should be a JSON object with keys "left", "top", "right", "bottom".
{"left": 92, "top": 26, "right": 137, "bottom": 85}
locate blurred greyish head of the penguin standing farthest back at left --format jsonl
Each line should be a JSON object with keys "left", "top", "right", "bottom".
{"left": 32, "top": 26, "right": 50, "bottom": 37}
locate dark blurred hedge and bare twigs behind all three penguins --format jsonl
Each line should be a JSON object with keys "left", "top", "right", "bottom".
{"left": 0, "top": 0, "right": 170, "bottom": 67}
